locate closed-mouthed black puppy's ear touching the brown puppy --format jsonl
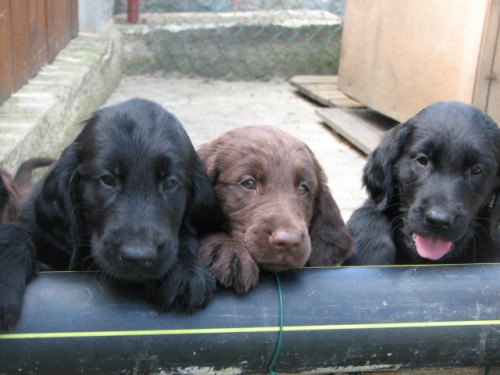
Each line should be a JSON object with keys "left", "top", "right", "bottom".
{"left": 189, "top": 153, "right": 225, "bottom": 233}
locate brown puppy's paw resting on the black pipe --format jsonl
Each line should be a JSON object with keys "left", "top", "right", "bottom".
{"left": 199, "top": 234, "right": 259, "bottom": 293}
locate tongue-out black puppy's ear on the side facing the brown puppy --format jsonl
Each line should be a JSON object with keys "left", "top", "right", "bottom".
{"left": 363, "top": 120, "right": 413, "bottom": 209}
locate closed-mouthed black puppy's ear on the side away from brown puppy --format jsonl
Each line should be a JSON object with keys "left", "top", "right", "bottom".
{"left": 32, "top": 143, "right": 80, "bottom": 268}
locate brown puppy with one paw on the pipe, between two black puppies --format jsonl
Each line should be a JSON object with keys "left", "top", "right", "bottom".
{"left": 198, "top": 126, "right": 352, "bottom": 293}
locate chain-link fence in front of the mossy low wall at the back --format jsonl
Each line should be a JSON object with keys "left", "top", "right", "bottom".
{"left": 115, "top": 0, "right": 345, "bottom": 80}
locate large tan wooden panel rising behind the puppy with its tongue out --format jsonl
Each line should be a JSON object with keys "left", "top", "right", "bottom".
{"left": 339, "top": 0, "right": 489, "bottom": 121}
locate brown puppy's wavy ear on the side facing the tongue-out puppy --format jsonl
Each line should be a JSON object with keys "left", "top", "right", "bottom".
{"left": 307, "top": 169, "right": 352, "bottom": 267}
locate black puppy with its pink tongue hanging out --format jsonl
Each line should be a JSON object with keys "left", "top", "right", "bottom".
{"left": 346, "top": 102, "right": 500, "bottom": 264}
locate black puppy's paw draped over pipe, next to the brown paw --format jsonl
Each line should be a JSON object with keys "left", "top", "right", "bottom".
{"left": 144, "top": 263, "right": 216, "bottom": 314}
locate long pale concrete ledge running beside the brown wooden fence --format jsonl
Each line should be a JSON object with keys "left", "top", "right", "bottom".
{"left": 0, "top": 22, "right": 121, "bottom": 173}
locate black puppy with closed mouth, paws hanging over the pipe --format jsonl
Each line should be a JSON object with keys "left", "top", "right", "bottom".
{"left": 0, "top": 99, "right": 222, "bottom": 328}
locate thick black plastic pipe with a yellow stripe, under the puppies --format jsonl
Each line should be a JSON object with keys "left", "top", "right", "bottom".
{"left": 0, "top": 264, "right": 500, "bottom": 374}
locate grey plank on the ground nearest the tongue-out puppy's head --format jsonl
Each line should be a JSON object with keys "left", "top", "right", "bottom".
{"left": 316, "top": 108, "right": 397, "bottom": 155}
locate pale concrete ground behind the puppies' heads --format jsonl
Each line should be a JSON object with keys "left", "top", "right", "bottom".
{"left": 105, "top": 75, "right": 365, "bottom": 220}
